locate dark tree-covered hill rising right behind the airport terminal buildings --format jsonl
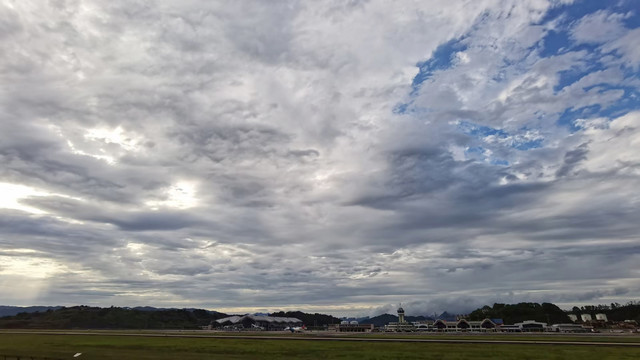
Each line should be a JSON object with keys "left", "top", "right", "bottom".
{"left": 468, "top": 303, "right": 571, "bottom": 324}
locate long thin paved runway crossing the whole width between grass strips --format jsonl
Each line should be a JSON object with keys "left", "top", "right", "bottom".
{"left": 0, "top": 331, "right": 640, "bottom": 348}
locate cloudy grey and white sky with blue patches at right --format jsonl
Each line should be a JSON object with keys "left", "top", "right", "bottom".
{"left": 0, "top": 0, "right": 640, "bottom": 315}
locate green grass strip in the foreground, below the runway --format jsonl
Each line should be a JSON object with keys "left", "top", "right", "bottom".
{"left": 0, "top": 333, "right": 640, "bottom": 360}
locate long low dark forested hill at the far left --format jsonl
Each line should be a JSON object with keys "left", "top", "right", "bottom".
{"left": 0, "top": 306, "right": 227, "bottom": 329}
